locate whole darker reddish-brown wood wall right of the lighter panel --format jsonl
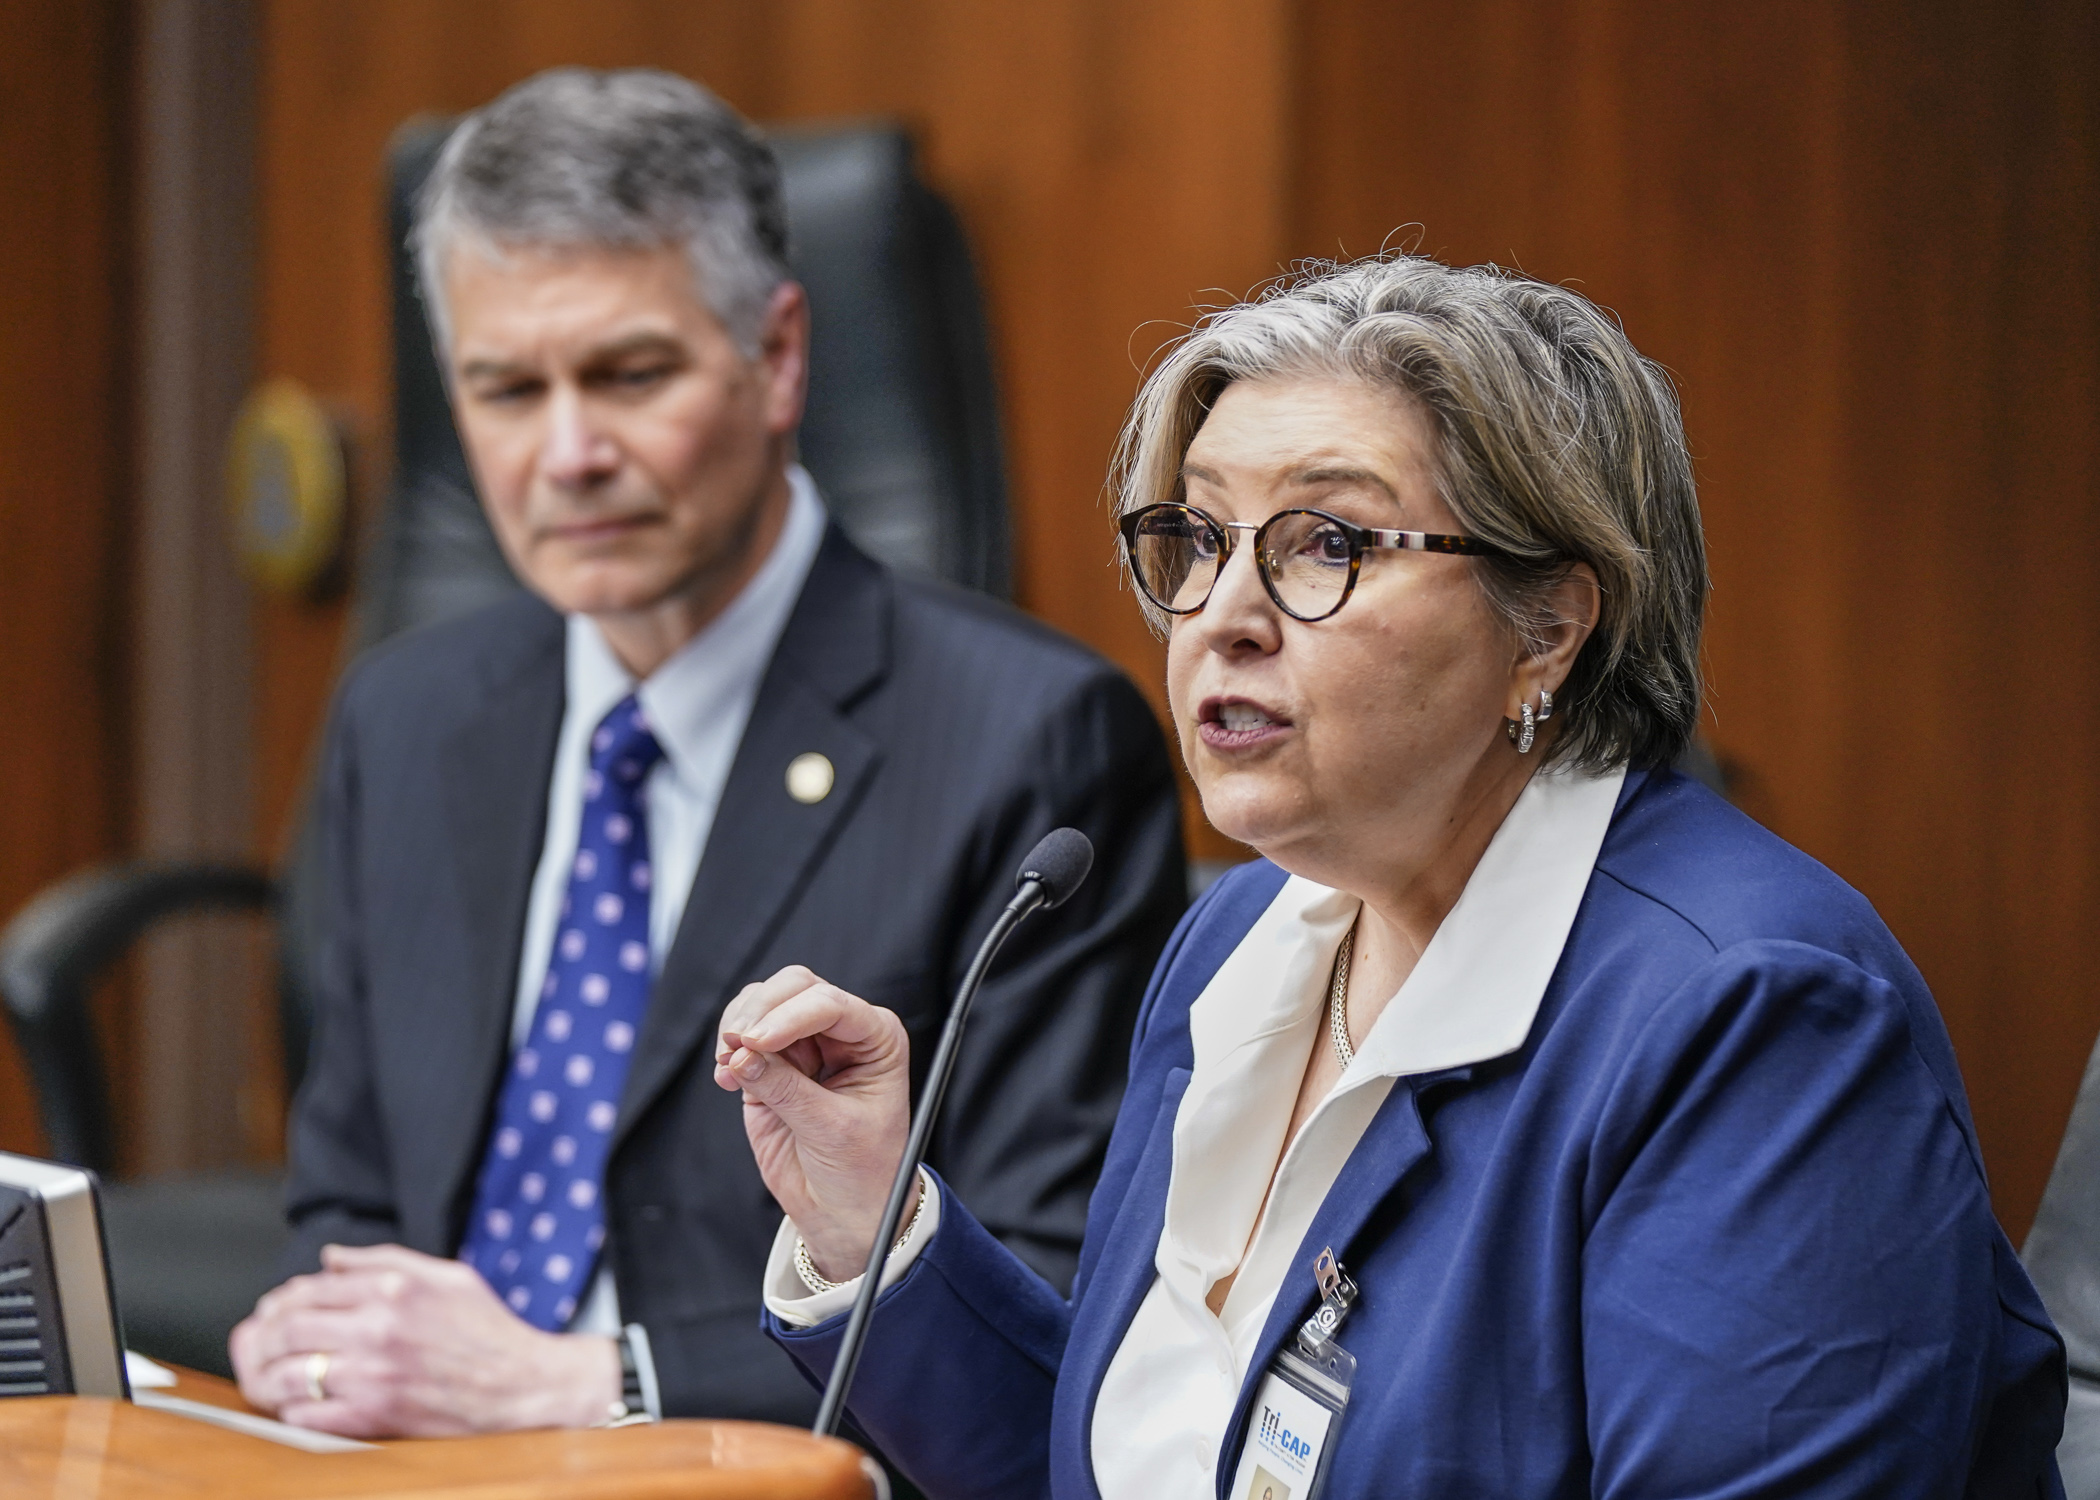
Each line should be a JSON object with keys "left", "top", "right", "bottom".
{"left": 1294, "top": 0, "right": 2100, "bottom": 1235}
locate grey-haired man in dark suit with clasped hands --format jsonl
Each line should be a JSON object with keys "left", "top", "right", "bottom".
{"left": 233, "top": 69, "right": 1182, "bottom": 1435}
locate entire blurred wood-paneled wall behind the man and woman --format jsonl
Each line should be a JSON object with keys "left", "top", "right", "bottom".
{"left": 0, "top": 0, "right": 2100, "bottom": 1237}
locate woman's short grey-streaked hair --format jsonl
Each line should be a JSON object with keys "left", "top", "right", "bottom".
{"left": 1113, "top": 254, "right": 1707, "bottom": 771}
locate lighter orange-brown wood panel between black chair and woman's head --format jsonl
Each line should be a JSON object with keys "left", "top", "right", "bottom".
{"left": 769, "top": 0, "right": 1292, "bottom": 857}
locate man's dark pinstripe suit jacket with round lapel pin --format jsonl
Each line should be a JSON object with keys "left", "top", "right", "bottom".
{"left": 286, "top": 527, "right": 1187, "bottom": 1422}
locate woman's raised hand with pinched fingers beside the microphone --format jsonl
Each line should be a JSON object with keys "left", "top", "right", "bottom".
{"left": 714, "top": 966, "right": 911, "bottom": 1282}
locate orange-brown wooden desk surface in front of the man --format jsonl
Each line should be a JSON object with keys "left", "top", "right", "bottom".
{"left": 0, "top": 1372, "right": 872, "bottom": 1500}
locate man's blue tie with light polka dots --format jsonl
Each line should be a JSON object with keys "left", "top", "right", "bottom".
{"left": 460, "top": 693, "right": 664, "bottom": 1330}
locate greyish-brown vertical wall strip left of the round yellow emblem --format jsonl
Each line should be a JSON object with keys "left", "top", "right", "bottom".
{"left": 133, "top": 0, "right": 266, "bottom": 1172}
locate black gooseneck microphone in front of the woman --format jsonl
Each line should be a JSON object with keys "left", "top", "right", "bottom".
{"left": 811, "top": 828, "right": 1094, "bottom": 1437}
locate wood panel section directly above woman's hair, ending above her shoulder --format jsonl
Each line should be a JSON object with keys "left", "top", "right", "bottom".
{"left": 1298, "top": 0, "right": 1848, "bottom": 840}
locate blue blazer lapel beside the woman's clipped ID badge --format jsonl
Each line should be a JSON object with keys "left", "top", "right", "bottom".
{"left": 1218, "top": 1067, "right": 1472, "bottom": 1500}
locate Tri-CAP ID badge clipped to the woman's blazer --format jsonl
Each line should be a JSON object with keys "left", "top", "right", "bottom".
{"left": 1226, "top": 1250, "right": 1357, "bottom": 1500}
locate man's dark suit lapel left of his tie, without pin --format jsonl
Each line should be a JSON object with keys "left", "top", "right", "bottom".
{"left": 426, "top": 611, "right": 567, "bottom": 1233}
